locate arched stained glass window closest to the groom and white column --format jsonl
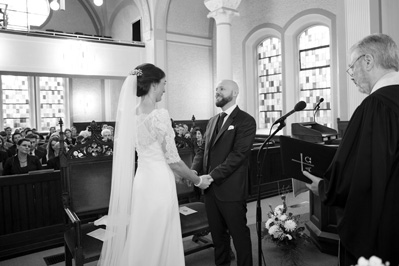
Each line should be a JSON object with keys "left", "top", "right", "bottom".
{"left": 258, "top": 37, "right": 283, "bottom": 130}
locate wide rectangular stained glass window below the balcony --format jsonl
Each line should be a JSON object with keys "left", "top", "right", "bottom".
{"left": 0, "top": 75, "right": 66, "bottom": 131}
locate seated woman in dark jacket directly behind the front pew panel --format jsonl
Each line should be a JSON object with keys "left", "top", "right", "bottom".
{"left": 3, "top": 139, "right": 42, "bottom": 175}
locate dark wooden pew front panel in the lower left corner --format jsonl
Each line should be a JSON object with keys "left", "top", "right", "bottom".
{"left": 0, "top": 170, "right": 64, "bottom": 260}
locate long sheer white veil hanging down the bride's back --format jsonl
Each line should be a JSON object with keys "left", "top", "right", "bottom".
{"left": 98, "top": 71, "right": 138, "bottom": 266}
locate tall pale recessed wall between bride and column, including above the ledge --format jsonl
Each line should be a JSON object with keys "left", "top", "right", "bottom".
{"left": 164, "top": 0, "right": 214, "bottom": 120}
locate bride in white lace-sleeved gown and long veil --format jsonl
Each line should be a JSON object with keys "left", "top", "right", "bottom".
{"left": 98, "top": 64, "right": 213, "bottom": 266}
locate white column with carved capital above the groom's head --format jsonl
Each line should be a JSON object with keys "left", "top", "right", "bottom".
{"left": 204, "top": 0, "right": 241, "bottom": 81}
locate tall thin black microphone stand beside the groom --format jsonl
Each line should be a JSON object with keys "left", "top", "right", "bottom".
{"left": 256, "top": 119, "right": 285, "bottom": 266}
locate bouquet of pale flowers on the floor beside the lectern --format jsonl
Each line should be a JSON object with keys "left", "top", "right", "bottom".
{"left": 262, "top": 194, "right": 310, "bottom": 266}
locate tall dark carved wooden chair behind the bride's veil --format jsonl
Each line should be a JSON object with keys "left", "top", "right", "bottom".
{"left": 60, "top": 121, "right": 113, "bottom": 266}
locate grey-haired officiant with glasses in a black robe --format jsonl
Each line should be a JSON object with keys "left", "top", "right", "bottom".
{"left": 304, "top": 34, "right": 399, "bottom": 266}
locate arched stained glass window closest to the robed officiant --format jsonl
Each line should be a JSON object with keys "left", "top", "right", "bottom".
{"left": 299, "top": 26, "right": 332, "bottom": 127}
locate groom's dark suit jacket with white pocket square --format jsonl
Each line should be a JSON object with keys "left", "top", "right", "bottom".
{"left": 191, "top": 107, "right": 256, "bottom": 201}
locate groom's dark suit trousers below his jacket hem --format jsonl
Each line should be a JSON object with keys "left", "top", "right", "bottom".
{"left": 205, "top": 186, "right": 252, "bottom": 266}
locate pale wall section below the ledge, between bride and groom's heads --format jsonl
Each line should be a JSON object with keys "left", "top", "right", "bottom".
{"left": 164, "top": 42, "right": 214, "bottom": 120}
